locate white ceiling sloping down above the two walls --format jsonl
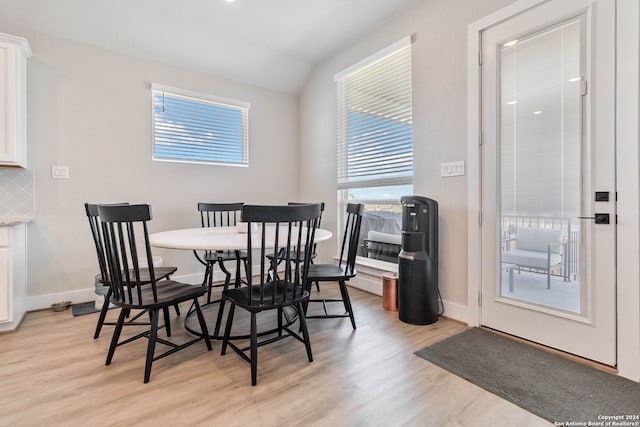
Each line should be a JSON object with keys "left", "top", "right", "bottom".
{"left": 0, "top": 0, "right": 420, "bottom": 94}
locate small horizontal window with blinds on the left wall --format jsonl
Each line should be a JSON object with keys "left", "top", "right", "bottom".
{"left": 151, "top": 84, "right": 250, "bottom": 166}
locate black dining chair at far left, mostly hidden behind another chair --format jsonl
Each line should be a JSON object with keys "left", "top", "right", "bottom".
{"left": 84, "top": 203, "right": 180, "bottom": 339}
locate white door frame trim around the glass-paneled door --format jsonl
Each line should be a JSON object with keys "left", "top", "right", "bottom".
{"left": 467, "top": 0, "right": 640, "bottom": 381}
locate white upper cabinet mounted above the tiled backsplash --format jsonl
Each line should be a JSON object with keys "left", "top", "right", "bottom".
{"left": 0, "top": 33, "right": 31, "bottom": 168}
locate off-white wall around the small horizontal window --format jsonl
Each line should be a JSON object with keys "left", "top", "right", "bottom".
{"left": 3, "top": 27, "right": 298, "bottom": 309}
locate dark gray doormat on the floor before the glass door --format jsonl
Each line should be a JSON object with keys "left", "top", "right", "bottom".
{"left": 415, "top": 328, "right": 640, "bottom": 426}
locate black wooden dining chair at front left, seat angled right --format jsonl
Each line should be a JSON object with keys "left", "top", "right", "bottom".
{"left": 98, "top": 205, "right": 211, "bottom": 383}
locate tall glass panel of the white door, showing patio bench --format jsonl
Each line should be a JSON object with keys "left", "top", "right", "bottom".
{"left": 497, "top": 18, "right": 588, "bottom": 313}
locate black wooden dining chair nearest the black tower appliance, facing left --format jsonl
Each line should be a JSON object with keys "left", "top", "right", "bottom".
{"left": 305, "top": 203, "right": 364, "bottom": 329}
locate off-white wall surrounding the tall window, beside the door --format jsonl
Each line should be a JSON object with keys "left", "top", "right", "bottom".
{"left": 300, "top": 0, "right": 511, "bottom": 310}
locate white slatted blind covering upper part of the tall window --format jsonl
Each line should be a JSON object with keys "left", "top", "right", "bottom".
{"left": 336, "top": 37, "right": 413, "bottom": 189}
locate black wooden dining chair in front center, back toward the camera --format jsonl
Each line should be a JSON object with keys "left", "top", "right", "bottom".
{"left": 214, "top": 204, "right": 320, "bottom": 385}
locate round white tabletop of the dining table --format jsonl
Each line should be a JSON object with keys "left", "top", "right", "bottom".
{"left": 149, "top": 227, "right": 332, "bottom": 251}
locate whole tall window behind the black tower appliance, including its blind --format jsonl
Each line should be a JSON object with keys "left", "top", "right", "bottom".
{"left": 336, "top": 37, "right": 413, "bottom": 268}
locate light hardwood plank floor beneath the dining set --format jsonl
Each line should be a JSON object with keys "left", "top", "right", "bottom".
{"left": 0, "top": 284, "right": 550, "bottom": 427}
